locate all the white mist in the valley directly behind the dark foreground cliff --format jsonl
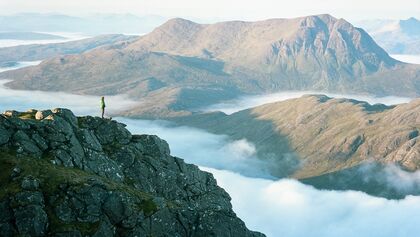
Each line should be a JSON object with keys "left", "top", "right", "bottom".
{"left": 0, "top": 81, "right": 420, "bottom": 237}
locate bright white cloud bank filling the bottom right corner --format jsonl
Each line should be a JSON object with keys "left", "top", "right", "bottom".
{"left": 204, "top": 168, "right": 420, "bottom": 237}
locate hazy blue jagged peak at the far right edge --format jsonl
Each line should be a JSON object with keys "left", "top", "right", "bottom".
{"left": 357, "top": 17, "right": 420, "bottom": 54}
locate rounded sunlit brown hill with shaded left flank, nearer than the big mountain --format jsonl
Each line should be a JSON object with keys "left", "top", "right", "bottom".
{"left": 170, "top": 96, "right": 420, "bottom": 197}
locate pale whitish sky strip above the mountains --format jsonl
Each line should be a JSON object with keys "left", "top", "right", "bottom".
{"left": 0, "top": 0, "right": 420, "bottom": 20}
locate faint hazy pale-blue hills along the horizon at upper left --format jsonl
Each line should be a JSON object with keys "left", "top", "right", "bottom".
{"left": 0, "top": 13, "right": 167, "bottom": 35}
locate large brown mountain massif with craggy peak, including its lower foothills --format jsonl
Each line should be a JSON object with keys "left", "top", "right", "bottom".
{"left": 1, "top": 15, "right": 420, "bottom": 117}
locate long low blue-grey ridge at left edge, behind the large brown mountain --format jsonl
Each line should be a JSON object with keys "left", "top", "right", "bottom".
{"left": 0, "top": 35, "right": 136, "bottom": 64}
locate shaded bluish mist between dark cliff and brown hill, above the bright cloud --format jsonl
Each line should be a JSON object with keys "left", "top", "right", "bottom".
{"left": 120, "top": 118, "right": 273, "bottom": 178}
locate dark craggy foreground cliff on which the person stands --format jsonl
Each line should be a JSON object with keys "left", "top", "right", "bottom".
{"left": 0, "top": 109, "right": 263, "bottom": 236}
